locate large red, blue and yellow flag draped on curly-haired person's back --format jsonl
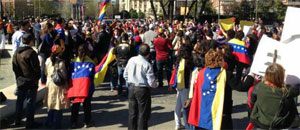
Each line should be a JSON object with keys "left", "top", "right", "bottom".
{"left": 188, "top": 68, "right": 226, "bottom": 130}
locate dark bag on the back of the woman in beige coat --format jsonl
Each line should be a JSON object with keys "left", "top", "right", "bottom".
{"left": 51, "top": 59, "right": 66, "bottom": 87}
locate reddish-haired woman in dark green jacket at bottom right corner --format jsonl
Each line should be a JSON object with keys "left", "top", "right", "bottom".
{"left": 250, "top": 63, "right": 300, "bottom": 129}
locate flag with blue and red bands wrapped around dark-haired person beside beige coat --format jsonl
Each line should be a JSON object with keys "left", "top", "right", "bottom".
{"left": 67, "top": 56, "right": 95, "bottom": 103}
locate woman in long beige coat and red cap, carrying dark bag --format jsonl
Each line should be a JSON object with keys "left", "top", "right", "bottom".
{"left": 44, "top": 45, "right": 70, "bottom": 129}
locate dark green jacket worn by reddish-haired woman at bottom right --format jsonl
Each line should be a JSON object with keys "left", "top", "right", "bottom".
{"left": 250, "top": 81, "right": 299, "bottom": 129}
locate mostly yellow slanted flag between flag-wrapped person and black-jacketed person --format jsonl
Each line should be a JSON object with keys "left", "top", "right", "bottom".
{"left": 94, "top": 48, "right": 116, "bottom": 86}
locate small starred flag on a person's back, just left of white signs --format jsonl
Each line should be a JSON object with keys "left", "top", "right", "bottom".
{"left": 228, "top": 39, "right": 251, "bottom": 65}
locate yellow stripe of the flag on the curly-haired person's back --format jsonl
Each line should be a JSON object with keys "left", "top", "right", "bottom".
{"left": 211, "top": 68, "right": 226, "bottom": 130}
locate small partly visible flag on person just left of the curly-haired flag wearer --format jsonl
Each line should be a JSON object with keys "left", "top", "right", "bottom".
{"left": 169, "top": 59, "right": 185, "bottom": 88}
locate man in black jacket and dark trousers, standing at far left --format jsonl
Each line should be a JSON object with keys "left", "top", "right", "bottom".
{"left": 12, "top": 33, "right": 41, "bottom": 128}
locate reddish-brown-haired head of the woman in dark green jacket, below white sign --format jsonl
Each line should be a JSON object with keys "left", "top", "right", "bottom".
{"left": 264, "top": 63, "right": 285, "bottom": 87}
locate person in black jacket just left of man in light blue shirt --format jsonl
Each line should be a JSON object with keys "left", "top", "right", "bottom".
{"left": 113, "top": 33, "right": 135, "bottom": 95}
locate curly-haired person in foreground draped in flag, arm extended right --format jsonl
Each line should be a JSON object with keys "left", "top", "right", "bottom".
{"left": 185, "top": 49, "right": 254, "bottom": 129}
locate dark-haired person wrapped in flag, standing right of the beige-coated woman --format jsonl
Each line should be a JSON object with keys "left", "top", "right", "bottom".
{"left": 68, "top": 44, "right": 95, "bottom": 128}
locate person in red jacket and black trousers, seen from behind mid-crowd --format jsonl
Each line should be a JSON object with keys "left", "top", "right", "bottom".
{"left": 153, "top": 29, "right": 172, "bottom": 87}
